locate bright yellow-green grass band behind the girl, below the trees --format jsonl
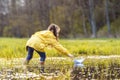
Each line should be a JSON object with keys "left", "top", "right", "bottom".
{"left": 0, "top": 38, "right": 120, "bottom": 58}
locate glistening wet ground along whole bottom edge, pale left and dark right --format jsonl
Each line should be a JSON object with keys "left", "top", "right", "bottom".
{"left": 0, "top": 64, "right": 120, "bottom": 80}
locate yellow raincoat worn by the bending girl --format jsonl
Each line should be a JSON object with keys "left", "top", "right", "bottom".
{"left": 26, "top": 30, "right": 69, "bottom": 55}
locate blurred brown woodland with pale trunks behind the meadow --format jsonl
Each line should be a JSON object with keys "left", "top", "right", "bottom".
{"left": 0, "top": 0, "right": 120, "bottom": 38}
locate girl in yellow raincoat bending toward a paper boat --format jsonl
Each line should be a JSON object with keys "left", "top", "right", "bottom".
{"left": 24, "top": 24, "right": 73, "bottom": 71}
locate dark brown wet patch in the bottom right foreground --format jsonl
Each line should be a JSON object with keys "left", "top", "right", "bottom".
{"left": 71, "top": 65, "right": 120, "bottom": 80}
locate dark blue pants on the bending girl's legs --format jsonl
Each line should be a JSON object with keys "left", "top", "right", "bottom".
{"left": 26, "top": 46, "right": 46, "bottom": 61}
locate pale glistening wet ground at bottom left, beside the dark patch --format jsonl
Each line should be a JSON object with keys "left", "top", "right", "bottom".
{"left": 0, "top": 65, "right": 69, "bottom": 80}
